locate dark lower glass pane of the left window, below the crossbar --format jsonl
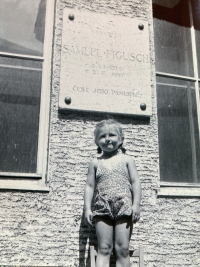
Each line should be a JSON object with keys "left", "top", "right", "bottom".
{"left": 0, "top": 57, "right": 42, "bottom": 173}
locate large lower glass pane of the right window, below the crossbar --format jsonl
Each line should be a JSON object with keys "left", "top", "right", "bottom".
{"left": 157, "top": 77, "right": 200, "bottom": 183}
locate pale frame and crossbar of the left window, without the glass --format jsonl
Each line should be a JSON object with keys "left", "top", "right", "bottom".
{"left": 0, "top": 0, "right": 55, "bottom": 192}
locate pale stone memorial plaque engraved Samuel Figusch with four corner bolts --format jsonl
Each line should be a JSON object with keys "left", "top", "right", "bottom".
{"left": 59, "top": 8, "right": 152, "bottom": 116}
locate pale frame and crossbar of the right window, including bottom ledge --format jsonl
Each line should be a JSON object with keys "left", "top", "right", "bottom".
{"left": 153, "top": 0, "right": 200, "bottom": 197}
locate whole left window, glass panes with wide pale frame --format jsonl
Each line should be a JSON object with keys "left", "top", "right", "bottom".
{"left": 0, "top": 0, "right": 54, "bottom": 193}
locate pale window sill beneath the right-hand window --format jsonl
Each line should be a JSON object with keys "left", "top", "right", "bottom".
{"left": 157, "top": 186, "right": 200, "bottom": 197}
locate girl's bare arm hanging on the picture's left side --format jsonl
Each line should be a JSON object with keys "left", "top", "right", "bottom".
{"left": 84, "top": 159, "right": 97, "bottom": 225}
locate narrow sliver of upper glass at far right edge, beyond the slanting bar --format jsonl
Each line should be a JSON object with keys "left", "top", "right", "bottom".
{"left": 192, "top": 0, "right": 200, "bottom": 77}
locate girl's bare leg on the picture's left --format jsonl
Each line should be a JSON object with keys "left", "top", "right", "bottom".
{"left": 95, "top": 216, "right": 113, "bottom": 267}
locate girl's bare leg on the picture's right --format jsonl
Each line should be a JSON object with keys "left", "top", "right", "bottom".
{"left": 115, "top": 216, "right": 132, "bottom": 267}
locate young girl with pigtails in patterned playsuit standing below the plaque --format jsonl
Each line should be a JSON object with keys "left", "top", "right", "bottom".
{"left": 84, "top": 119, "right": 141, "bottom": 267}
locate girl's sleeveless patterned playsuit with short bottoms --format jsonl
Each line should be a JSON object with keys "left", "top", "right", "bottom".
{"left": 93, "top": 154, "right": 132, "bottom": 220}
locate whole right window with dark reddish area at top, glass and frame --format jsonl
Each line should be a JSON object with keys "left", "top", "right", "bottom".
{"left": 153, "top": 0, "right": 200, "bottom": 195}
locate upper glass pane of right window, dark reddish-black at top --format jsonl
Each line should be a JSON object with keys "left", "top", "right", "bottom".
{"left": 153, "top": 0, "right": 194, "bottom": 76}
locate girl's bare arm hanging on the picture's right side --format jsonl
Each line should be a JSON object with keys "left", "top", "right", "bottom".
{"left": 127, "top": 156, "right": 142, "bottom": 222}
